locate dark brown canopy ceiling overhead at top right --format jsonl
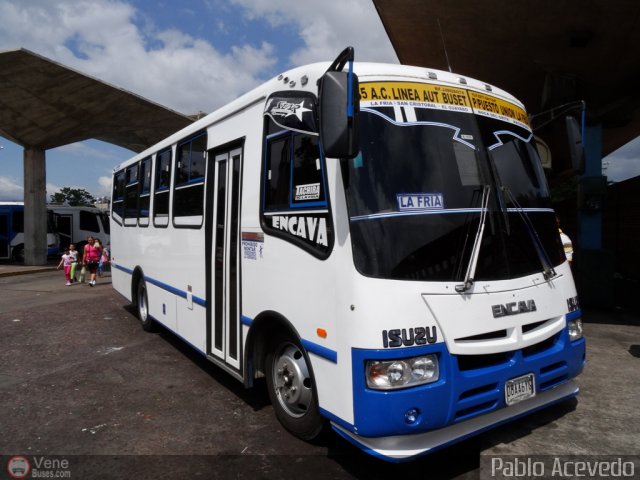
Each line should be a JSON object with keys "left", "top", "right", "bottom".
{"left": 373, "top": 0, "right": 640, "bottom": 155}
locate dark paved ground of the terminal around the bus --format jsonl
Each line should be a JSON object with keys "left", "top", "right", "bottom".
{"left": 0, "top": 266, "right": 640, "bottom": 479}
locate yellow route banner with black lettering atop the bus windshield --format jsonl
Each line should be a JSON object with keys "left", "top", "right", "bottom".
{"left": 360, "top": 82, "right": 531, "bottom": 130}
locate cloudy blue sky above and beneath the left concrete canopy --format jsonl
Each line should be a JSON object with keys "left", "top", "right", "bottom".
{"left": 0, "top": 0, "right": 398, "bottom": 200}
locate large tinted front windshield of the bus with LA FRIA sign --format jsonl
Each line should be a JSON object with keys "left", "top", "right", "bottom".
{"left": 341, "top": 107, "right": 564, "bottom": 281}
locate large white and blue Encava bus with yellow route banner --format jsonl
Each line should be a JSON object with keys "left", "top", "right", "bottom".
{"left": 111, "top": 49, "right": 585, "bottom": 461}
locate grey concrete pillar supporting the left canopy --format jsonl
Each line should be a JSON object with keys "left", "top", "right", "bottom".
{"left": 24, "top": 148, "right": 47, "bottom": 265}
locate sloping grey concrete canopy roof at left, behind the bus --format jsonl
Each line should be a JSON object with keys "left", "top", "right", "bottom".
{"left": 0, "top": 49, "right": 193, "bottom": 152}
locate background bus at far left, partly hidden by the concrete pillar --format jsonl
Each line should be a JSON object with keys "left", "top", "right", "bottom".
{"left": 0, "top": 202, "right": 60, "bottom": 262}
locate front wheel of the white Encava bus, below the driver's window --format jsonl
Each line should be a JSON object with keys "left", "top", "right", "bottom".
{"left": 266, "top": 335, "right": 324, "bottom": 441}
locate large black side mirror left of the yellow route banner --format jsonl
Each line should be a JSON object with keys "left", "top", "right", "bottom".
{"left": 318, "top": 71, "right": 360, "bottom": 158}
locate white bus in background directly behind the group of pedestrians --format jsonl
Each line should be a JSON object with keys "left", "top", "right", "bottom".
{"left": 47, "top": 204, "right": 111, "bottom": 252}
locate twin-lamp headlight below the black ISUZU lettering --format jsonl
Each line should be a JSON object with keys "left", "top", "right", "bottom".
{"left": 365, "top": 355, "right": 440, "bottom": 390}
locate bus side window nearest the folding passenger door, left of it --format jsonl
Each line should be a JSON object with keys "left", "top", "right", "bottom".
{"left": 173, "top": 132, "right": 207, "bottom": 228}
